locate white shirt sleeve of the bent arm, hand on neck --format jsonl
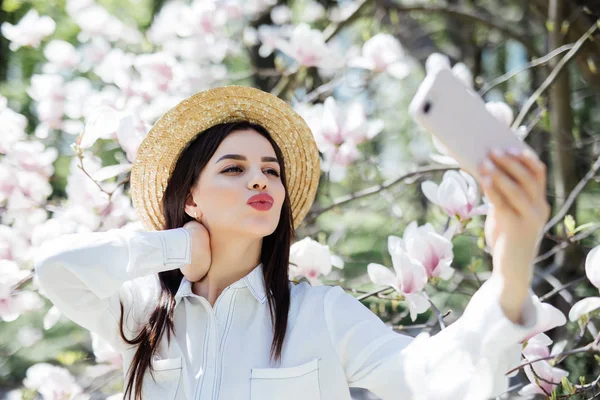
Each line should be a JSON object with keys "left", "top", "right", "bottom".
{"left": 34, "top": 228, "right": 191, "bottom": 350}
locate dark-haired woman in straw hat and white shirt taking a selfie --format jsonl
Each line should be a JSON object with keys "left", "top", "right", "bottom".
{"left": 35, "top": 86, "right": 548, "bottom": 400}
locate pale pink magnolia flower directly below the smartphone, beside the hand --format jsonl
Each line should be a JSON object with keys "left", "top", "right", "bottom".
{"left": 421, "top": 170, "right": 489, "bottom": 221}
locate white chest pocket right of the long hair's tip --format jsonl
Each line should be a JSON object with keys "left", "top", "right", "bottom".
{"left": 250, "top": 358, "right": 321, "bottom": 400}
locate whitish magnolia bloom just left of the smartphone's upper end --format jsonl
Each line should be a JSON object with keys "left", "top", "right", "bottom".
{"left": 349, "top": 33, "right": 410, "bottom": 79}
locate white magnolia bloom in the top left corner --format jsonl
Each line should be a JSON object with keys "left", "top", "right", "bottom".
{"left": 0, "top": 8, "right": 56, "bottom": 51}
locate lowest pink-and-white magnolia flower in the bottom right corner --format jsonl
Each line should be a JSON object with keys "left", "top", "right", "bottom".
{"left": 519, "top": 333, "right": 569, "bottom": 396}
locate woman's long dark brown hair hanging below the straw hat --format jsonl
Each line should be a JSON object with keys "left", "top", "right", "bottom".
{"left": 120, "top": 121, "right": 294, "bottom": 400}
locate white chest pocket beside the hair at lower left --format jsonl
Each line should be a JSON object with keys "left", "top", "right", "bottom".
{"left": 142, "top": 357, "right": 182, "bottom": 400}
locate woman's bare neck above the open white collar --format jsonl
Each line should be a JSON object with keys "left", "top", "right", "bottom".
{"left": 192, "top": 232, "right": 262, "bottom": 306}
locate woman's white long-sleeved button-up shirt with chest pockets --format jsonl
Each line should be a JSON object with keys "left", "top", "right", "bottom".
{"left": 34, "top": 228, "right": 538, "bottom": 400}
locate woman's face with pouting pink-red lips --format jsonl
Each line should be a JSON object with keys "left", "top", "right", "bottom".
{"left": 186, "top": 129, "right": 285, "bottom": 238}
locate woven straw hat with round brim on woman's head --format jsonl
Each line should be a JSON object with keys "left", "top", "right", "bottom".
{"left": 130, "top": 86, "right": 320, "bottom": 230}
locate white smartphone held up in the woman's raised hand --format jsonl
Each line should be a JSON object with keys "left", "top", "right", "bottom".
{"left": 408, "top": 69, "right": 531, "bottom": 182}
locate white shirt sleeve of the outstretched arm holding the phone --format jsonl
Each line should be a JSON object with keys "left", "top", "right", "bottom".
{"left": 324, "top": 275, "right": 538, "bottom": 400}
